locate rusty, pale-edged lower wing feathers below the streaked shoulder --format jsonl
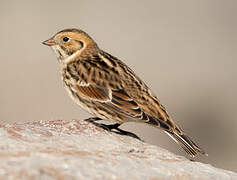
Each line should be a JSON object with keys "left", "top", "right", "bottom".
{"left": 76, "top": 79, "right": 171, "bottom": 131}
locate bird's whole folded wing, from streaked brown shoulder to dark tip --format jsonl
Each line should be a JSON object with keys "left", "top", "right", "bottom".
{"left": 67, "top": 54, "right": 172, "bottom": 131}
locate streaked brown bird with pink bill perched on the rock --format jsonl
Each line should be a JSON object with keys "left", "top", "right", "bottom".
{"left": 42, "top": 28, "right": 207, "bottom": 158}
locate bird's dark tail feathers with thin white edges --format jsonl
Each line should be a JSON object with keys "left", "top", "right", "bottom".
{"left": 165, "top": 131, "right": 208, "bottom": 157}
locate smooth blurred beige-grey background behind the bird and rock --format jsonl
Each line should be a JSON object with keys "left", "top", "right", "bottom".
{"left": 0, "top": 0, "right": 237, "bottom": 171}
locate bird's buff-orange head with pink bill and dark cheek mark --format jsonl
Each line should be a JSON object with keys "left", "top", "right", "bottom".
{"left": 43, "top": 29, "right": 98, "bottom": 62}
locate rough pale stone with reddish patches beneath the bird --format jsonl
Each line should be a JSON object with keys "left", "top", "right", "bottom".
{"left": 0, "top": 120, "right": 237, "bottom": 180}
